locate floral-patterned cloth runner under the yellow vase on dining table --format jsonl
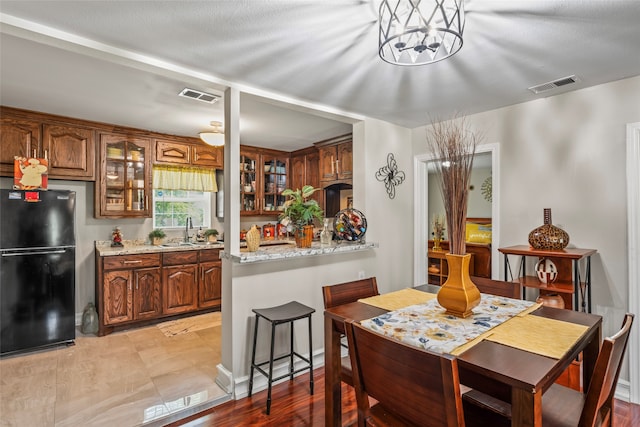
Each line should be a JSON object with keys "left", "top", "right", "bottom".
{"left": 361, "top": 291, "right": 540, "bottom": 354}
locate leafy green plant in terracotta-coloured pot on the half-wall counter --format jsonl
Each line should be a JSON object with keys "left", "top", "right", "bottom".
{"left": 280, "top": 185, "right": 324, "bottom": 248}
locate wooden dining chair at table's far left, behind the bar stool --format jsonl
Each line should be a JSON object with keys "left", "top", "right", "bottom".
{"left": 322, "top": 277, "right": 380, "bottom": 386}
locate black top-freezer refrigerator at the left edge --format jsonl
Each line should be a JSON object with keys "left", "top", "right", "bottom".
{"left": 0, "top": 189, "right": 76, "bottom": 355}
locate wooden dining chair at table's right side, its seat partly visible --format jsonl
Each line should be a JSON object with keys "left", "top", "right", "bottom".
{"left": 463, "top": 313, "right": 634, "bottom": 427}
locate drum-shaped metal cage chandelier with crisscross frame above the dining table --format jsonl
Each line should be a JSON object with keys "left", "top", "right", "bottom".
{"left": 378, "top": 0, "right": 464, "bottom": 65}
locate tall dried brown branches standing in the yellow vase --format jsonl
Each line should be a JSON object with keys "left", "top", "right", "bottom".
{"left": 427, "top": 118, "right": 479, "bottom": 255}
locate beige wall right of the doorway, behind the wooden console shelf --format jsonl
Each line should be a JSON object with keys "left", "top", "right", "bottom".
{"left": 413, "top": 77, "right": 640, "bottom": 386}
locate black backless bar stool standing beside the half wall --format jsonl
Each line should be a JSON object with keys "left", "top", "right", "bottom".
{"left": 249, "top": 301, "right": 316, "bottom": 415}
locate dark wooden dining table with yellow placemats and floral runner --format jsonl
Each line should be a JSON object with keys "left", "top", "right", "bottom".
{"left": 324, "top": 285, "right": 602, "bottom": 427}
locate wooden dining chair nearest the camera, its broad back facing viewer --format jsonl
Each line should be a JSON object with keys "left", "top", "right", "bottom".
{"left": 345, "top": 320, "right": 465, "bottom": 427}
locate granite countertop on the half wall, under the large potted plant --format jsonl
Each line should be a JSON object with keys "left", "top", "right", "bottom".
{"left": 220, "top": 242, "right": 378, "bottom": 264}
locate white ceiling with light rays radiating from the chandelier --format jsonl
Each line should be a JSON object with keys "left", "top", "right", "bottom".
{"left": 0, "top": 0, "right": 640, "bottom": 150}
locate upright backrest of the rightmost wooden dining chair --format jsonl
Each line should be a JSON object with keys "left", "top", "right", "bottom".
{"left": 578, "top": 313, "right": 634, "bottom": 427}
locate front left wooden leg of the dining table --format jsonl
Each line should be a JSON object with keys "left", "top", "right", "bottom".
{"left": 324, "top": 314, "right": 342, "bottom": 427}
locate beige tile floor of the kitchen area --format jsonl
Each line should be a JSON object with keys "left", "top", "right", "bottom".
{"left": 0, "top": 313, "right": 229, "bottom": 427}
